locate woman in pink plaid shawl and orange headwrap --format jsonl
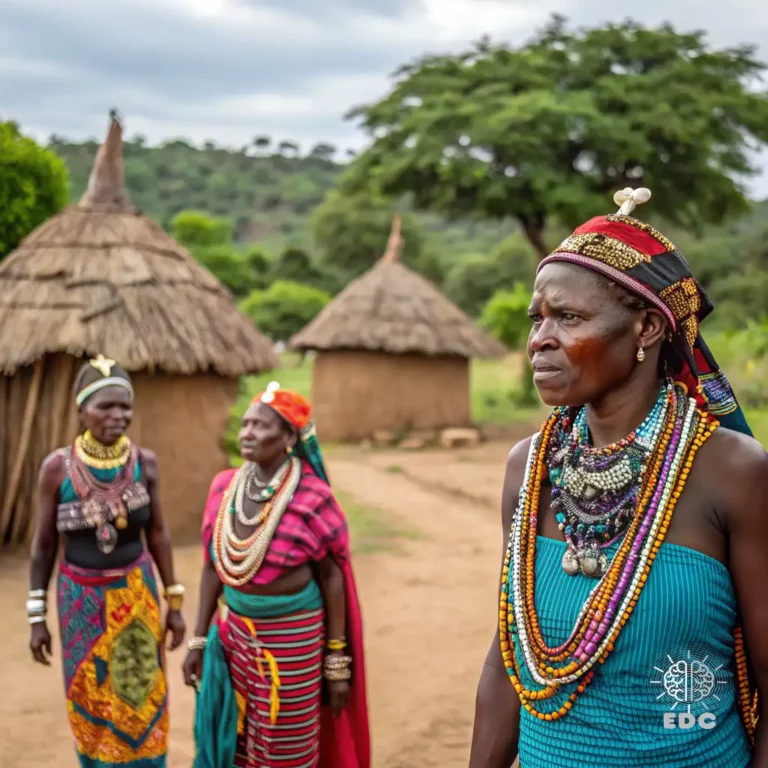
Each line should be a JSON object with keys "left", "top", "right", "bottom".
{"left": 184, "top": 382, "right": 370, "bottom": 768}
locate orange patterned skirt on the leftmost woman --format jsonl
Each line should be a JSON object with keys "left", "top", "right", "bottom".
{"left": 58, "top": 553, "right": 168, "bottom": 768}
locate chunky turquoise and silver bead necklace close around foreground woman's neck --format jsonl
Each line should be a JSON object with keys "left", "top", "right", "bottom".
{"left": 548, "top": 387, "right": 670, "bottom": 578}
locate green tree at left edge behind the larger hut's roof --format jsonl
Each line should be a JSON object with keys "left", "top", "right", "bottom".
{"left": 0, "top": 122, "right": 68, "bottom": 259}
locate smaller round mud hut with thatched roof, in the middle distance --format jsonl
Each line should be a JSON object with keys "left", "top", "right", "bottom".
{"left": 290, "top": 217, "right": 505, "bottom": 442}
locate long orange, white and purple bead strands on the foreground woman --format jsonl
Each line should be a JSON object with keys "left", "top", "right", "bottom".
{"left": 499, "top": 387, "right": 718, "bottom": 721}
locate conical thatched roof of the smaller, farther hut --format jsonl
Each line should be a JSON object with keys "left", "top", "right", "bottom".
{"left": 290, "top": 217, "right": 505, "bottom": 357}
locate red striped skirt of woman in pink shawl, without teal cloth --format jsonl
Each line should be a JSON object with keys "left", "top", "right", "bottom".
{"left": 219, "top": 608, "right": 325, "bottom": 768}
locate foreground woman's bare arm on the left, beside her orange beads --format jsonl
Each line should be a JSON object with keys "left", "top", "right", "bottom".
{"left": 469, "top": 438, "right": 531, "bottom": 768}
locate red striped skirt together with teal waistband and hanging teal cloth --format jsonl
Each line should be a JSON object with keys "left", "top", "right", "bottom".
{"left": 195, "top": 582, "right": 325, "bottom": 768}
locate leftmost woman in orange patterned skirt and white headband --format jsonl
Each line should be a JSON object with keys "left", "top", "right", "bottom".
{"left": 27, "top": 355, "right": 184, "bottom": 768}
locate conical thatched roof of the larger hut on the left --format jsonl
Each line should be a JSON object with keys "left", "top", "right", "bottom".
{"left": 0, "top": 115, "right": 277, "bottom": 376}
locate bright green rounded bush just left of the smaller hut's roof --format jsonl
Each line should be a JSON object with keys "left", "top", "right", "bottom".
{"left": 240, "top": 280, "right": 331, "bottom": 341}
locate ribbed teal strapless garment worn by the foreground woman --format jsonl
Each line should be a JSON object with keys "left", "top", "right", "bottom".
{"left": 519, "top": 536, "right": 750, "bottom": 768}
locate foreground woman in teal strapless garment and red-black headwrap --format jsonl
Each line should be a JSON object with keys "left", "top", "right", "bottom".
{"left": 470, "top": 189, "right": 768, "bottom": 768}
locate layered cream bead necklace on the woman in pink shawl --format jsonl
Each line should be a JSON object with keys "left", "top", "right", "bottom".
{"left": 212, "top": 457, "right": 301, "bottom": 587}
